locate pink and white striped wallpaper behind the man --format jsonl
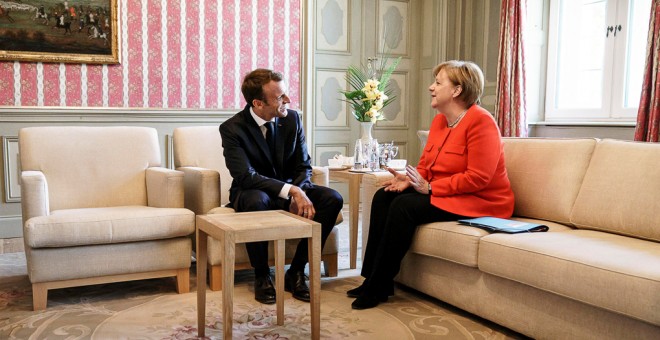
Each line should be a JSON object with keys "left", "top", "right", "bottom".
{"left": 0, "top": 0, "right": 300, "bottom": 109}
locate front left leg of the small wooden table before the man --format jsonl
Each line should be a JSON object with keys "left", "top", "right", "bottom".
{"left": 222, "top": 232, "right": 236, "bottom": 339}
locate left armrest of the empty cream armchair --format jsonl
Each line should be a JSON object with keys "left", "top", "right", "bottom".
{"left": 21, "top": 171, "right": 50, "bottom": 224}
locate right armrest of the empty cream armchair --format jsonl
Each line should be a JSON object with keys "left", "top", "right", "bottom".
{"left": 146, "top": 167, "right": 183, "bottom": 208}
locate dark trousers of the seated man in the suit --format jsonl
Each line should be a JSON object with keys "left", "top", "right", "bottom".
{"left": 232, "top": 185, "right": 344, "bottom": 276}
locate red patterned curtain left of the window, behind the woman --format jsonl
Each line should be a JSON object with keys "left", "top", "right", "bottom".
{"left": 495, "top": 0, "right": 527, "bottom": 137}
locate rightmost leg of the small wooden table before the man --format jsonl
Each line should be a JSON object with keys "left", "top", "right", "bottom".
{"left": 307, "top": 223, "right": 321, "bottom": 339}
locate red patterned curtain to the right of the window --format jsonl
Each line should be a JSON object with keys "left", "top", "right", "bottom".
{"left": 635, "top": 0, "right": 660, "bottom": 142}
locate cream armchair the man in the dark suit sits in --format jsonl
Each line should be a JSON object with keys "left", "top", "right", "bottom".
{"left": 174, "top": 126, "right": 341, "bottom": 291}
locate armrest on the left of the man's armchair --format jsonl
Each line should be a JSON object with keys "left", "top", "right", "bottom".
{"left": 177, "top": 166, "right": 221, "bottom": 215}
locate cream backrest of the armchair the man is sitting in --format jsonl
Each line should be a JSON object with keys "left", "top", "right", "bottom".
{"left": 174, "top": 125, "right": 232, "bottom": 205}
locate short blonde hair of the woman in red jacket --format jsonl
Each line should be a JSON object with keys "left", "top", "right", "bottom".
{"left": 433, "top": 60, "right": 484, "bottom": 105}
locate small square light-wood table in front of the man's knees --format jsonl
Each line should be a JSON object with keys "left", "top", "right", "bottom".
{"left": 197, "top": 210, "right": 321, "bottom": 339}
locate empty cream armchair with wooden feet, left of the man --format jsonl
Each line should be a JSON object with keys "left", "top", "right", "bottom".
{"left": 19, "top": 127, "right": 195, "bottom": 310}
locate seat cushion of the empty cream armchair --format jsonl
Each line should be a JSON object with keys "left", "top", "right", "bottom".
{"left": 23, "top": 206, "right": 195, "bottom": 248}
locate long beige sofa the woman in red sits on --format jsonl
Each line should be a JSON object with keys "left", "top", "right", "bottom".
{"left": 361, "top": 138, "right": 660, "bottom": 339}
